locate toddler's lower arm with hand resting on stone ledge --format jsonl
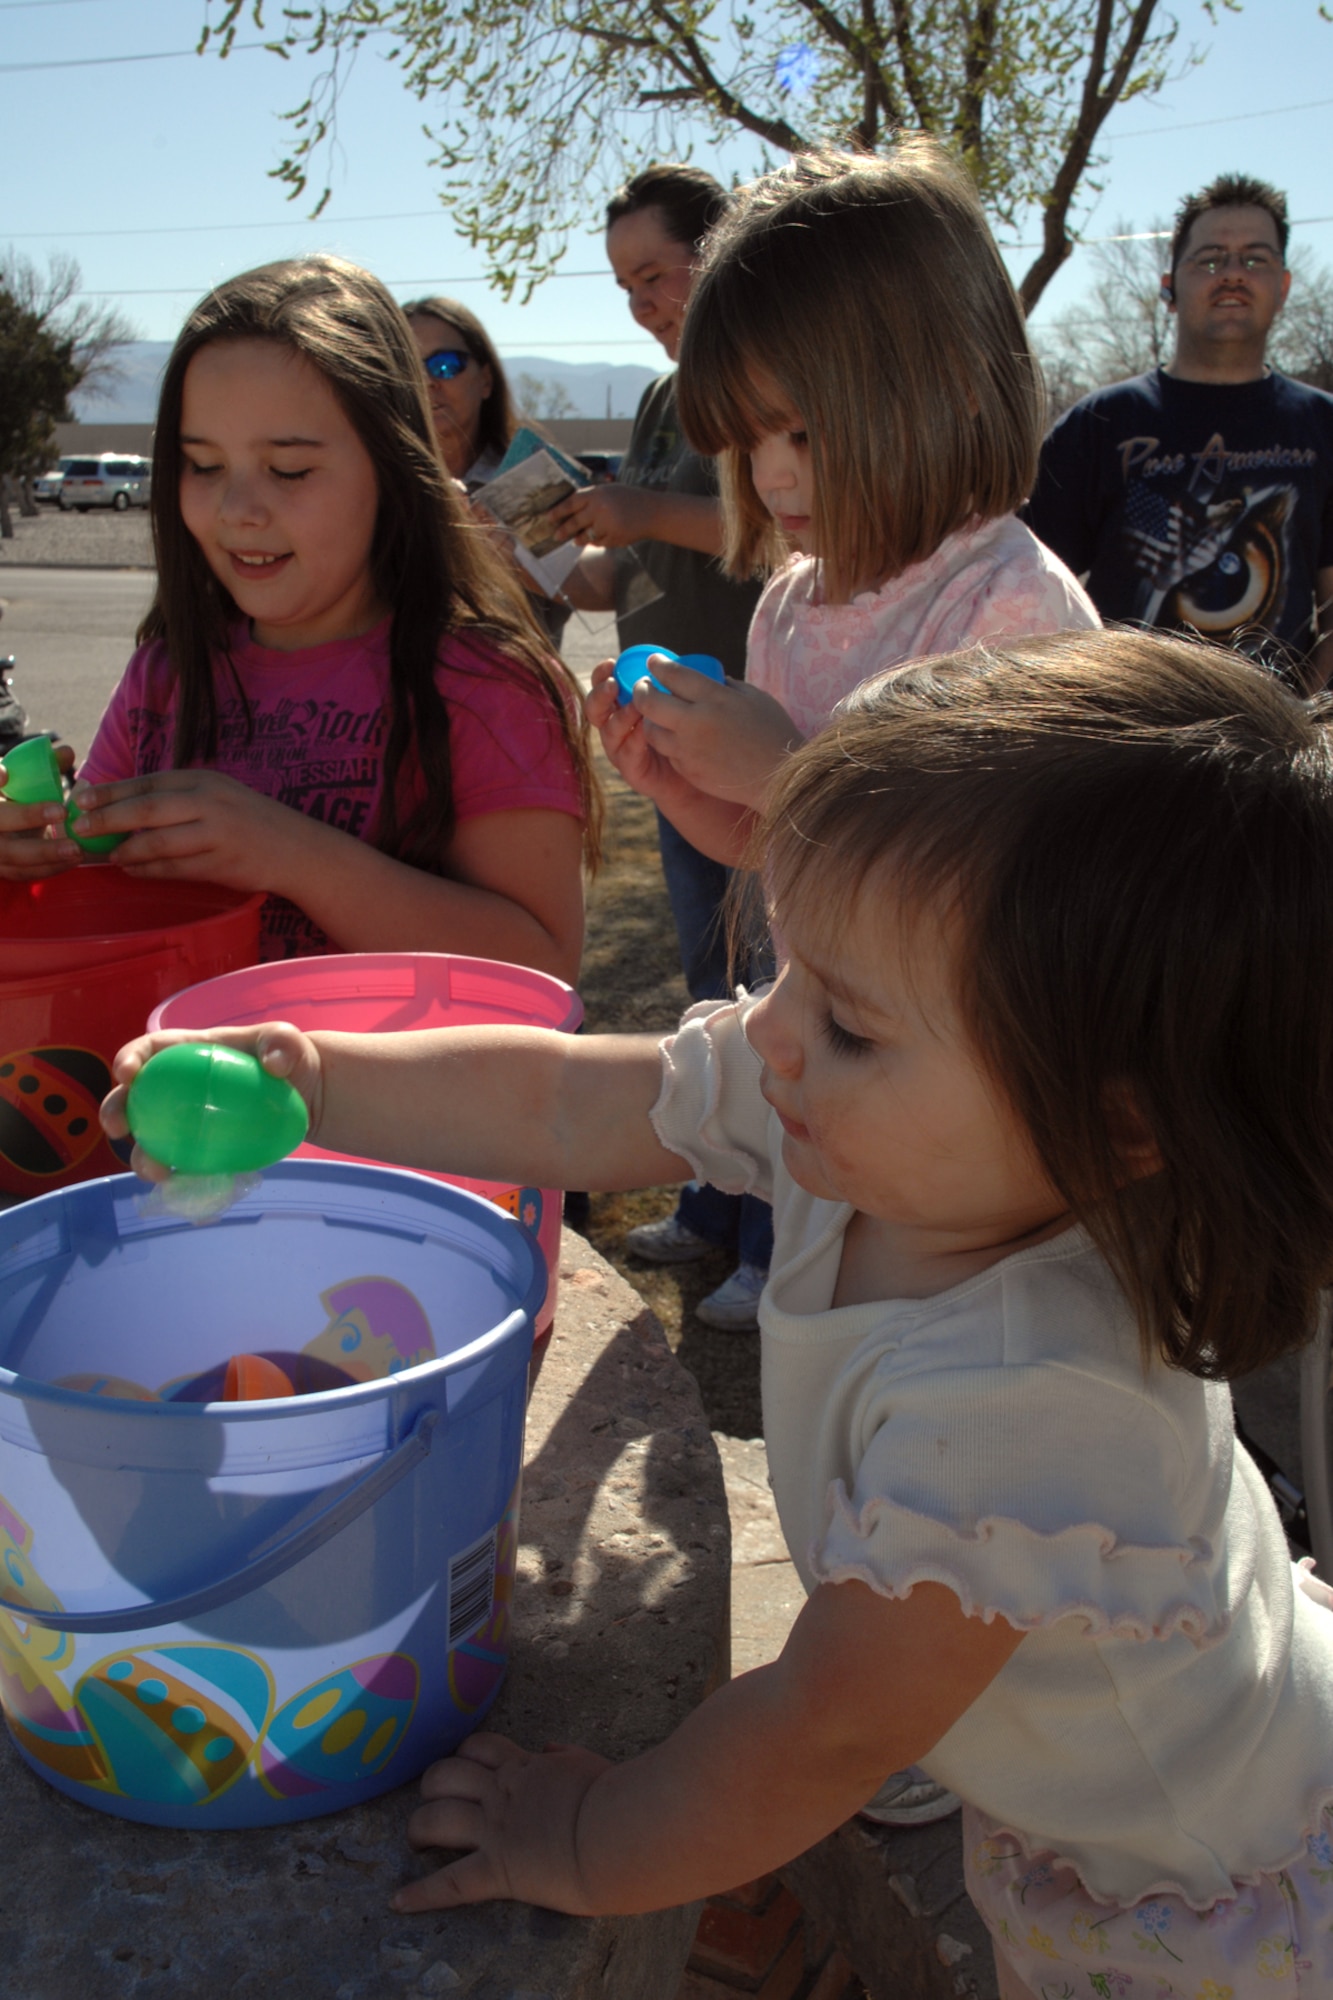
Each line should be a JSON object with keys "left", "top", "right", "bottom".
{"left": 394, "top": 1582, "right": 1023, "bottom": 1916}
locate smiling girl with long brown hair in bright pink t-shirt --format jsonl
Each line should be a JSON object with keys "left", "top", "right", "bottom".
{"left": 0, "top": 256, "right": 598, "bottom": 980}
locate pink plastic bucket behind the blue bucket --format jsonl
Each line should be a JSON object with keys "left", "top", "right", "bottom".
{"left": 148, "top": 952, "right": 582, "bottom": 1338}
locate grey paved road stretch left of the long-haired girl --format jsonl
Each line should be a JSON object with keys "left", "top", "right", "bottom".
{"left": 0, "top": 568, "right": 154, "bottom": 756}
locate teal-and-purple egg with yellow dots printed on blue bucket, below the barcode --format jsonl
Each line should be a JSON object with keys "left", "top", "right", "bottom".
{"left": 258, "top": 1652, "right": 420, "bottom": 1798}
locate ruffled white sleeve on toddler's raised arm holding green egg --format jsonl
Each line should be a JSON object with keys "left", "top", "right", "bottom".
{"left": 650, "top": 990, "right": 773, "bottom": 1202}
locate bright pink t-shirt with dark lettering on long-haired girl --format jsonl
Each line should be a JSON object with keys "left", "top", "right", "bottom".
{"left": 80, "top": 618, "right": 582, "bottom": 958}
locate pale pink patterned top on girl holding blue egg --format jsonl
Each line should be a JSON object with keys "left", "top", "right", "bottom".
{"left": 745, "top": 514, "right": 1101, "bottom": 736}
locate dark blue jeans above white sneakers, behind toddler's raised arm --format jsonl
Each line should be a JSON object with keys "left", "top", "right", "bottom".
{"left": 656, "top": 812, "right": 773, "bottom": 1270}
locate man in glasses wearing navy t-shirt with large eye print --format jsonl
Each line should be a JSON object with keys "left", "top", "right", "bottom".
{"left": 1027, "top": 174, "right": 1333, "bottom": 690}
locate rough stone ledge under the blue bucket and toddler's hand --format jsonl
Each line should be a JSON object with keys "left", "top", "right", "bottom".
{"left": 0, "top": 1232, "right": 731, "bottom": 2000}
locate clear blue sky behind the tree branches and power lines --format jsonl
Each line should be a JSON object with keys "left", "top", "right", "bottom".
{"left": 0, "top": 0, "right": 1333, "bottom": 366}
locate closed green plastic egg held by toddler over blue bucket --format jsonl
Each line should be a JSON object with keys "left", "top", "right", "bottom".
{"left": 126, "top": 1042, "right": 308, "bottom": 1174}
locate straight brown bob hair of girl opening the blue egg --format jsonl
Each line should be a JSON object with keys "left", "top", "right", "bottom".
{"left": 681, "top": 138, "right": 1045, "bottom": 604}
